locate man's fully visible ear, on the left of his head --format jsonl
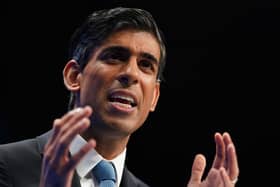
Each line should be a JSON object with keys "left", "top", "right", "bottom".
{"left": 63, "top": 59, "right": 81, "bottom": 91}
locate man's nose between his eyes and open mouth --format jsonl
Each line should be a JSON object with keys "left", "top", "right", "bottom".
{"left": 118, "top": 59, "right": 139, "bottom": 87}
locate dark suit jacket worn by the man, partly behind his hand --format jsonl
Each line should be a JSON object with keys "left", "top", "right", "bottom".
{"left": 0, "top": 131, "right": 148, "bottom": 187}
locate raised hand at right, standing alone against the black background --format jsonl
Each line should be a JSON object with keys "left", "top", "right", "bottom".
{"left": 187, "top": 133, "right": 239, "bottom": 187}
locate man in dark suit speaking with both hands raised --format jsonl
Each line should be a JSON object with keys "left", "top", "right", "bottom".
{"left": 0, "top": 7, "right": 239, "bottom": 187}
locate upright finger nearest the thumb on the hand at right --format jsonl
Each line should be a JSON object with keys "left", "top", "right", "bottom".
{"left": 212, "top": 133, "right": 226, "bottom": 169}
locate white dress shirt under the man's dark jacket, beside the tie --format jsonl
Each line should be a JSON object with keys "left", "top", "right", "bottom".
{"left": 69, "top": 135, "right": 126, "bottom": 187}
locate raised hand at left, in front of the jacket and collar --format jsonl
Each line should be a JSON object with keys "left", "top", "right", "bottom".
{"left": 40, "top": 106, "right": 96, "bottom": 187}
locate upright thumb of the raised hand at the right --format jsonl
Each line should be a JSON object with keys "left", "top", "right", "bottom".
{"left": 188, "top": 154, "right": 206, "bottom": 187}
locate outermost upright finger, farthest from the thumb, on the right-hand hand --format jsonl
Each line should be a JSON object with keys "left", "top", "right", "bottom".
{"left": 223, "top": 133, "right": 239, "bottom": 180}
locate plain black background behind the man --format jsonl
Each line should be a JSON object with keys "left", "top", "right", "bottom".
{"left": 0, "top": 0, "right": 280, "bottom": 186}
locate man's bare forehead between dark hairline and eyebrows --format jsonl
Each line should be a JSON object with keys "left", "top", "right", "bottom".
{"left": 100, "top": 30, "right": 160, "bottom": 61}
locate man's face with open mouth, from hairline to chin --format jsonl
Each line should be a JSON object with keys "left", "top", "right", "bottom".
{"left": 79, "top": 30, "right": 160, "bottom": 135}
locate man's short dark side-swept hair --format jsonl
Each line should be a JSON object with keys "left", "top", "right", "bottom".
{"left": 69, "top": 7, "right": 166, "bottom": 108}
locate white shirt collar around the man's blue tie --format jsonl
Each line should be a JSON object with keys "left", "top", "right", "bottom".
{"left": 69, "top": 135, "right": 126, "bottom": 186}
